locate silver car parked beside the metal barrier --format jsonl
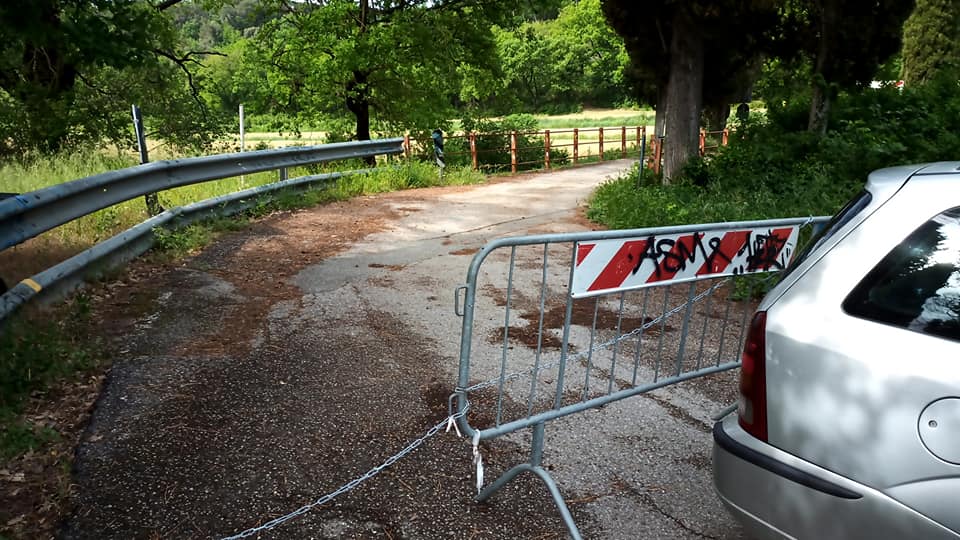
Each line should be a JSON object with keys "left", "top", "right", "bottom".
{"left": 713, "top": 163, "right": 960, "bottom": 539}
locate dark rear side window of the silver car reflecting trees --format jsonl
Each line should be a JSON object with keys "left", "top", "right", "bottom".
{"left": 843, "top": 207, "right": 960, "bottom": 341}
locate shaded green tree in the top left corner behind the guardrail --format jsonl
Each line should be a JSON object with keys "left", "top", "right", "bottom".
{"left": 0, "top": 0, "right": 227, "bottom": 155}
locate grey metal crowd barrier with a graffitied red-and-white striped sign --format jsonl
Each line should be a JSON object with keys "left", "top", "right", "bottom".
{"left": 452, "top": 218, "right": 827, "bottom": 538}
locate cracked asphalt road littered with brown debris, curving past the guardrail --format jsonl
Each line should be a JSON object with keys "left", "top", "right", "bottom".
{"left": 61, "top": 160, "right": 741, "bottom": 539}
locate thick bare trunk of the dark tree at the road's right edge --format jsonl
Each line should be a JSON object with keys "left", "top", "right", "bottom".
{"left": 663, "top": 8, "right": 704, "bottom": 184}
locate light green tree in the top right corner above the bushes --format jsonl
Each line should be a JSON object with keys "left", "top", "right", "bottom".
{"left": 900, "top": 0, "right": 960, "bottom": 86}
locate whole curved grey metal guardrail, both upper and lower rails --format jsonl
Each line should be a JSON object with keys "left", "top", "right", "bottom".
{"left": 0, "top": 138, "right": 403, "bottom": 322}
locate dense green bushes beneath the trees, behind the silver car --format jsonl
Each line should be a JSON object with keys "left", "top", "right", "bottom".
{"left": 588, "top": 70, "right": 960, "bottom": 228}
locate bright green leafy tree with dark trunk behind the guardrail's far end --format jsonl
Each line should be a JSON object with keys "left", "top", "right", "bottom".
{"left": 256, "top": 0, "right": 503, "bottom": 148}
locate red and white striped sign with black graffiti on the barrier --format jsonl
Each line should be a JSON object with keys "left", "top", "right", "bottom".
{"left": 571, "top": 226, "right": 798, "bottom": 298}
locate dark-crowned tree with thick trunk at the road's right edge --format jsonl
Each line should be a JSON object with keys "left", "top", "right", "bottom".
{"left": 603, "top": 0, "right": 777, "bottom": 183}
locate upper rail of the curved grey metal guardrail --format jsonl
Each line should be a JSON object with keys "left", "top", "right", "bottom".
{"left": 0, "top": 138, "right": 403, "bottom": 251}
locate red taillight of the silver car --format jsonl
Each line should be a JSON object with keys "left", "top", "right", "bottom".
{"left": 737, "top": 311, "right": 767, "bottom": 441}
